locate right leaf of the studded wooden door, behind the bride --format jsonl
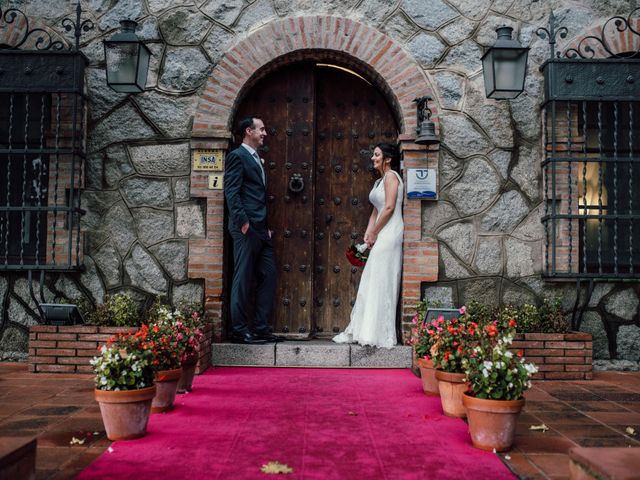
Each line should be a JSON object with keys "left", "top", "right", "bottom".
{"left": 314, "top": 68, "right": 397, "bottom": 336}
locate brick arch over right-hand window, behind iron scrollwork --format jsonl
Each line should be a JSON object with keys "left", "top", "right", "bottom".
{"left": 564, "top": 18, "right": 640, "bottom": 58}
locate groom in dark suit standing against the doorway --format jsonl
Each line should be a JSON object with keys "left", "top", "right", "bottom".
{"left": 224, "top": 117, "right": 282, "bottom": 344}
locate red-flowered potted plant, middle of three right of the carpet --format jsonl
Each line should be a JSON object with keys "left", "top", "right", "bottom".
{"left": 431, "top": 307, "right": 478, "bottom": 418}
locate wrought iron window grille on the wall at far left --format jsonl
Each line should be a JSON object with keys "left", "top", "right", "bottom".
{"left": 0, "top": 2, "right": 94, "bottom": 313}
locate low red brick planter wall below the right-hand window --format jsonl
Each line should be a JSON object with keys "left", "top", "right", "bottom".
{"left": 512, "top": 332, "right": 593, "bottom": 380}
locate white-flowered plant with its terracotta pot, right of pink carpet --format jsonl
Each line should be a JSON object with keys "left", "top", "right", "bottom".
{"left": 462, "top": 319, "right": 538, "bottom": 452}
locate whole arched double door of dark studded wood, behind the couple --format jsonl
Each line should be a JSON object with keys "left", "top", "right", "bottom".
{"left": 236, "top": 62, "right": 397, "bottom": 337}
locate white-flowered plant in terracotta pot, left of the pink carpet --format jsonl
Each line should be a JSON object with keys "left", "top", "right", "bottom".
{"left": 91, "top": 335, "right": 156, "bottom": 440}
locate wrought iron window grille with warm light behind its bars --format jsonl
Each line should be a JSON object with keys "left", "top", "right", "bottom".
{"left": 537, "top": 8, "right": 640, "bottom": 329}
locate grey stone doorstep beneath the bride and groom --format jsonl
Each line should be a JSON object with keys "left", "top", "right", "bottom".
{"left": 212, "top": 340, "right": 412, "bottom": 368}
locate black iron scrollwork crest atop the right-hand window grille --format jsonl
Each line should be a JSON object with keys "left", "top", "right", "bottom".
{"left": 564, "top": 8, "right": 640, "bottom": 59}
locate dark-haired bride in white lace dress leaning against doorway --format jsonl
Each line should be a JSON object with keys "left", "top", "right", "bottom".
{"left": 333, "top": 143, "right": 404, "bottom": 348}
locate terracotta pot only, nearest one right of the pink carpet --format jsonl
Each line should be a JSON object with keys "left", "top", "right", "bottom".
{"left": 462, "top": 393, "right": 524, "bottom": 452}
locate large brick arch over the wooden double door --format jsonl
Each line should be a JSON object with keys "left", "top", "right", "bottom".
{"left": 192, "top": 16, "right": 433, "bottom": 140}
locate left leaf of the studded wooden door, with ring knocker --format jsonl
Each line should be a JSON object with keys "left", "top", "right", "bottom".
{"left": 237, "top": 64, "right": 314, "bottom": 336}
